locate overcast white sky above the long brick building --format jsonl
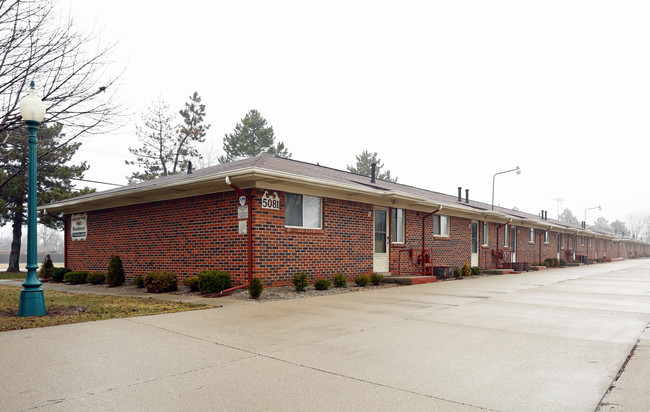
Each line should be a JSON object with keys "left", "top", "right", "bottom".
{"left": 61, "top": 0, "right": 650, "bottom": 223}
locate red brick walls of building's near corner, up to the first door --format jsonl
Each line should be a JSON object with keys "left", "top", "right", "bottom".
{"left": 67, "top": 190, "right": 373, "bottom": 285}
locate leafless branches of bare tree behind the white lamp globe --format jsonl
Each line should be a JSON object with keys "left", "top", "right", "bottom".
{"left": 0, "top": 0, "right": 120, "bottom": 144}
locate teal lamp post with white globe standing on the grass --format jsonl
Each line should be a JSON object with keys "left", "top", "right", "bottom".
{"left": 18, "top": 82, "right": 46, "bottom": 316}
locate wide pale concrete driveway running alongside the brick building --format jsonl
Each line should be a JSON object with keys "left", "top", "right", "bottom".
{"left": 0, "top": 260, "right": 650, "bottom": 411}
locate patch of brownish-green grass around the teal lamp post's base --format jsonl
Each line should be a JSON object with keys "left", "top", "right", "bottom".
{"left": 0, "top": 285, "right": 210, "bottom": 332}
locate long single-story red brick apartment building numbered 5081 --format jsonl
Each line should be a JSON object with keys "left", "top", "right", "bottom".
{"left": 40, "top": 155, "right": 650, "bottom": 286}
